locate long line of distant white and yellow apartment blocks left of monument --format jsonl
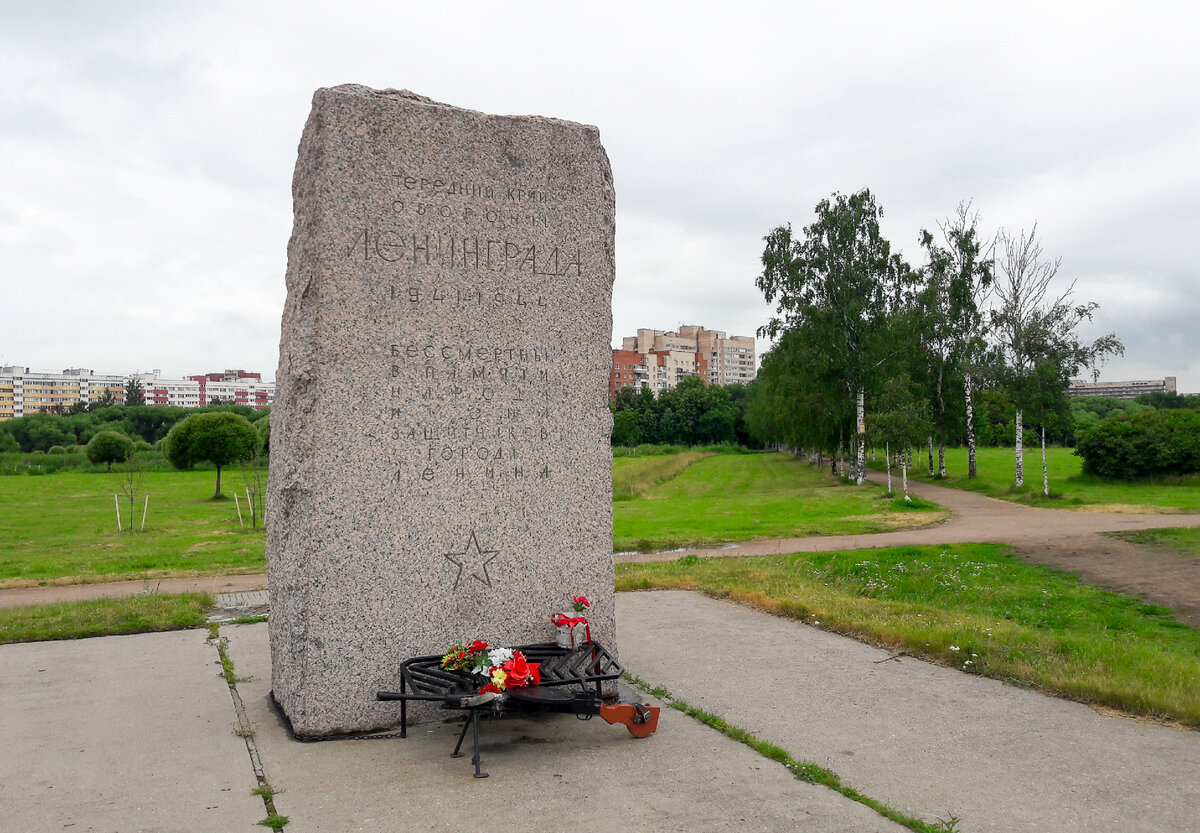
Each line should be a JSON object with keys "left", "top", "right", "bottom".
{"left": 0, "top": 366, "right": 275, "bottom": 420}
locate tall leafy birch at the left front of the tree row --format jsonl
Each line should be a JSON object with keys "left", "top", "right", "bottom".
{"left": 756, "top": 188, "right": 916, "bottom": 485}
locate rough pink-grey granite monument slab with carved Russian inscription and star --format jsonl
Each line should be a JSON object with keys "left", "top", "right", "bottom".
{"left": 266, "top": 85, "right": 616, "bottom": 736}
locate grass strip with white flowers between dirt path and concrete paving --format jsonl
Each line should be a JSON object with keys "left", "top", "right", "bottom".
{"left": 617, "top": 544, "right": 1200, "bottom": 726}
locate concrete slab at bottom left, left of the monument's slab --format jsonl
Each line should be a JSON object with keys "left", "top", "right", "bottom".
{"left": 0, "top": 630, "right": 266, "bottom": 833}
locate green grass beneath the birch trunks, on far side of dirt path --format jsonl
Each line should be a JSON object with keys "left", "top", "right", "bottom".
{"left": 871, "top": 448, "right": 1200, "bottom": 513}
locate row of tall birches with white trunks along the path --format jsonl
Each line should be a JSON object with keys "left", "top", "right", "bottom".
{"left": 745, "top": 190, "right": 1123, "bottom": 486}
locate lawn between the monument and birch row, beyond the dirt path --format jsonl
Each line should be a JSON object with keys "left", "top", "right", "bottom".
{"left": 613, "top": 454, "right": 946, "bottom": 552}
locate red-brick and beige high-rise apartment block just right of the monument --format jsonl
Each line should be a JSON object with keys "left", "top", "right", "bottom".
{"left": 608, "top": 324, "right": 757, "bottom": 396}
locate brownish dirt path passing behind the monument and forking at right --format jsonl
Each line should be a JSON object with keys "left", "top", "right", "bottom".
{"left": 9, "top": 472, "right": 1200, "bottom": 628}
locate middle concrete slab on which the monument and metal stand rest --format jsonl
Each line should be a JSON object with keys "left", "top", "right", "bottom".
{"left": 221, "top": 625, "right": 904, "bottom": 833}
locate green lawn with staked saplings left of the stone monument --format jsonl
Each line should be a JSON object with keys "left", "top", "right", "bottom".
{"left": 0, "top": 469, "right": 266, "bottom": 588}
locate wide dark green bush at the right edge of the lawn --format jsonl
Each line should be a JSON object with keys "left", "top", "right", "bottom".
{"left": 1075, "top": 410, "right": 1200, "bottom": 480}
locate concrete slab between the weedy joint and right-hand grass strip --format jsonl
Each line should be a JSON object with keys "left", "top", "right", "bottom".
{"left": 617, "top": 592, "right": 1200, "bottom": 833}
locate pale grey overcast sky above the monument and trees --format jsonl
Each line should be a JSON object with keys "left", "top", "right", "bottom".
{"left": 0, "top": 0, "right": 1200, "bottom": 392}
